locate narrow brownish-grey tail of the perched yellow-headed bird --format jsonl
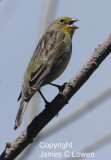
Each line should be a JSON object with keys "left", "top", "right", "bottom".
{"left": 14, "top": 100, "right": 28, "bottom": 130}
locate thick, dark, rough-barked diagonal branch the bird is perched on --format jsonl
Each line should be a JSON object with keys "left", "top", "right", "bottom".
{"left": 0, "top": 34, "right": 111, "bottom": 160}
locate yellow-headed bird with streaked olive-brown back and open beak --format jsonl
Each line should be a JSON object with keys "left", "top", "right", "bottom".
{"left": 14, "top": 17, "right": 78, "bottom": 130}
